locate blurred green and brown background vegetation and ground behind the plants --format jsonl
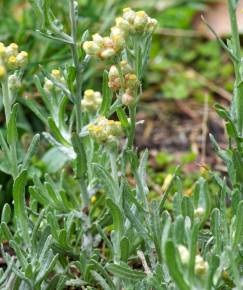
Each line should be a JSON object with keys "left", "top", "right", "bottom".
{"left": 0, "top": 0, "right": 236, "bottom": 206}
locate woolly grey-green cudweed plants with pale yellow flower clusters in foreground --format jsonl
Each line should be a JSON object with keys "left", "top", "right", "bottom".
{"left": 0, "top": 0, "right": 243, "bottom": 290}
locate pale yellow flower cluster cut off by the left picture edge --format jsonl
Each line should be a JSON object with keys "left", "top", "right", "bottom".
{"left": 0, "top": 42, "right": 28, "bottom": 79}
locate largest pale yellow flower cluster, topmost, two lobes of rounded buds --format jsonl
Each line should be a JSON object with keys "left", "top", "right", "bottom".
{"left": 83, "top": 8, "right": 157, "bottom": 59}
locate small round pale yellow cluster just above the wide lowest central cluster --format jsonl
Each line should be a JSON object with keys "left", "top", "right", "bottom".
{"left": 81, "top": 90, "right": 102, "bottom": 113}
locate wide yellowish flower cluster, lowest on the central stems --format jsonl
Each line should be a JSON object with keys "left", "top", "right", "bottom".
{"left": 88, "top": 116, "right": 123, "bottom": 144}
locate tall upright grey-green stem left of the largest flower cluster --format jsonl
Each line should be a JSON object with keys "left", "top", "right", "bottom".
{"left": 69, "top": 0, "right": 82, "bottom": 134}
